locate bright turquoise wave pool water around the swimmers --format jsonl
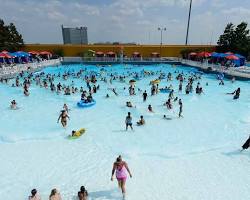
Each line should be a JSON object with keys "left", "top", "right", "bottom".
{"left": 0, "top": 64, "right": 250, "bottom": 200}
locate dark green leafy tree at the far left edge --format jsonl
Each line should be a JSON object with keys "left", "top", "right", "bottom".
{"left": 0, "top": 19, "right": 24, "bottom": 51}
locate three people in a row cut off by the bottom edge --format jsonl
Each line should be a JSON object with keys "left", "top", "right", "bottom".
{"left": 28, "top": 186, "right": 88, "bottom": 200}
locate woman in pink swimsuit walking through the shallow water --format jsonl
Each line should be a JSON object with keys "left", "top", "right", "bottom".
{"left": 111, "top": 156, "right": 132, "bottom": 199}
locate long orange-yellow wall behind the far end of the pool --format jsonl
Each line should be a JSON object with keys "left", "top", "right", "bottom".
{"left": 23, "top": 44, "right": 215, "bottom": 57}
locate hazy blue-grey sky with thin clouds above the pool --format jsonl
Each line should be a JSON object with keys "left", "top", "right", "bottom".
{"left": 0, "top": 0, "right": 250, "bottom": 44}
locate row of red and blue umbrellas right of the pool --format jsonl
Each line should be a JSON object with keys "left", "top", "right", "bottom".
{"left": 189, "top": 51, "right": 245, "bottom": 60}
